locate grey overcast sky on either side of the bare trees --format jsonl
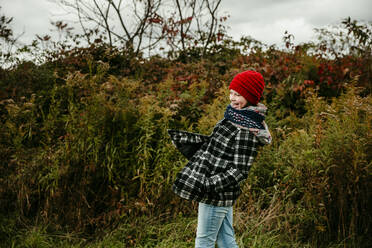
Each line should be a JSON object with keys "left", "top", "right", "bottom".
{"left": 0, "top": 0, "right": 372, "bottom": 45}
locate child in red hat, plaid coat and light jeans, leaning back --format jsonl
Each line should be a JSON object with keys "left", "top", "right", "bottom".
{"left": 169, "top": 71, "right": 271, "bottom": 248}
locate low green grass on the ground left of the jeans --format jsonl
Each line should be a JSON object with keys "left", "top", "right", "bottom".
{"left": 5, "top": 217, "right": 196, "bottom": 248}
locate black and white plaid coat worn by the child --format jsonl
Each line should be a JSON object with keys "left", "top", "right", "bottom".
{"left": 169, "top": 119, "right": 259, "bottom": 206}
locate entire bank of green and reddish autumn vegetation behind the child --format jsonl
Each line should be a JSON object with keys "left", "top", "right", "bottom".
{"left": 0, "top": 12, "right": 372, "bottom": 247}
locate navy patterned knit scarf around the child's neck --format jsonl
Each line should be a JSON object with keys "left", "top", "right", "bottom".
{"left": 224, "top": 105, "right": 265, "bottom": 129}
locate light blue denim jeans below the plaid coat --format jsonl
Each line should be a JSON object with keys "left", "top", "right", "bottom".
{"left": 195, "top": 203, "right": 238, "bottom": 248}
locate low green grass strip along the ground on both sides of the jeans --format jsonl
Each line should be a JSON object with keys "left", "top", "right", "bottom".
{"left": 4, "top": 213, "right": 364, "bottom": 248}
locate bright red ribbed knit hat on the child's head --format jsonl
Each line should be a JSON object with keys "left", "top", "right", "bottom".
{"left": 229, "top": 71, "right": 265, "bottom": 105}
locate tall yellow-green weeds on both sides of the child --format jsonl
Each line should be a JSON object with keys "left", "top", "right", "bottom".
{"left": 0, "top": 67, "right": 372, "bottom": 247}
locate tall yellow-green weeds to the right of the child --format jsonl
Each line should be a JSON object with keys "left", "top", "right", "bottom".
{"left": 238, "top": 87, "right": 372, "bottom": 247}
